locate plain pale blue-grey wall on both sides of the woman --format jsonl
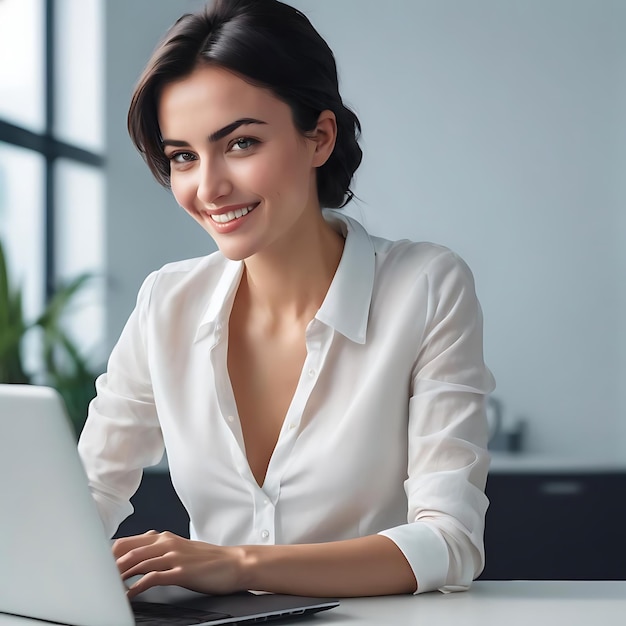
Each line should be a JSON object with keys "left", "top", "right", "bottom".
{"left": 107, "top": 0, "right": 626, "bottom": 459}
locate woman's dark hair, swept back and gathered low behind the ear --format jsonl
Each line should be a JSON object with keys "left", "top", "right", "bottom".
{"left": 128, "top": 0, "right": 362, "bottom": 208}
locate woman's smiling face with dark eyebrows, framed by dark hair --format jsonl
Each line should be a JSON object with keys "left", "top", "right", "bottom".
{"left": 159, "top": 66, "right": 334, "bottom": 260}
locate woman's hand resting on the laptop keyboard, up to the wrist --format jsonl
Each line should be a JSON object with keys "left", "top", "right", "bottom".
{"left": 113, "top": 530, "right": 244, "bottom": 598}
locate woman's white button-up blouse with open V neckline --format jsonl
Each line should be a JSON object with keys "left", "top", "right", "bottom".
{"left": 79, "top": 212, "right": 493, "bottom": 592}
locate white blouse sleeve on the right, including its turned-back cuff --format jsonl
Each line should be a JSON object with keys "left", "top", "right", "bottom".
{"left": 380, "top": 251, "right": 494, "bottom": 593}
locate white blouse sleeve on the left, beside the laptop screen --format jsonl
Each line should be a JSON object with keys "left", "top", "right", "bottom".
{"left": 78, "top": 273, "right": 164, "bottom": 536}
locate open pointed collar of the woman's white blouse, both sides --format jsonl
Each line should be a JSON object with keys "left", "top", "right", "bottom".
{"left": 196, "top": 210, "right": 375, "bottom": 343}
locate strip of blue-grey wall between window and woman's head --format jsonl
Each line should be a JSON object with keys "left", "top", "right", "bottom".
{"left": 105, "top": 0, "right": 208, "bottom": 344}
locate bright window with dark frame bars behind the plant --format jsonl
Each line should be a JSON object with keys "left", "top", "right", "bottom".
{"left": 0, "top": 0, "right": 105, "bottom": 368}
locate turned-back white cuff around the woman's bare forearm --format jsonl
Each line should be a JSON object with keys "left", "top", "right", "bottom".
{"left": 378, "top": 522, "right": 449, "bottom": 594}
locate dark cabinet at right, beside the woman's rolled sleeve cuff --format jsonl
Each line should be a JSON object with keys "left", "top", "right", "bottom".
{"left": 481, "top": 472, "right": 626, "bottom": 580}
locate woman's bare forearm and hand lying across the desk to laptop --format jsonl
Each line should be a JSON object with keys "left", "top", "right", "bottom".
{"left": 113, "top": 531, "right": 417, "bottom": 597}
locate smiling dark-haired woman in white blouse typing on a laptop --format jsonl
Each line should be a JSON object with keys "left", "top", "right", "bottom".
{"left": 80, "top": 0, "right": 493, "bottom": 596}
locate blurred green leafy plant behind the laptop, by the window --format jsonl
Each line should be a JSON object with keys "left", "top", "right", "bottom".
{"left": 0, "top": 235, "right": 99, "bottom": 434}
